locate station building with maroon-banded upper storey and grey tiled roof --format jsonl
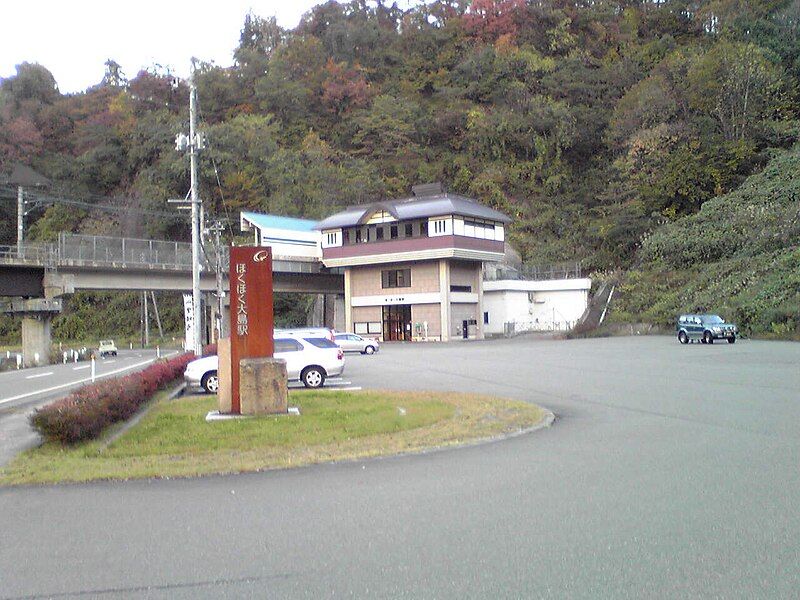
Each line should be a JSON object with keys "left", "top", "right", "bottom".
{"left": 316, "top": 186, "right": 510, "bottom": 341}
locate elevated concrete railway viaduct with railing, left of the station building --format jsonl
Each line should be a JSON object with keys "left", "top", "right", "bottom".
{"left": 0, "top": 234, "right": 344, "bottom": 365}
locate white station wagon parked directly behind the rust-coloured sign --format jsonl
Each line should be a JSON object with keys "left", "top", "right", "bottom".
{"left": 183, "top": 336, "right": 344, "bottom": 394}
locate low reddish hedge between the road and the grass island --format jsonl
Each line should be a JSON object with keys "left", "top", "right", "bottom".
{"left": 30, "top": 353, "right": 194, "bottom": 444}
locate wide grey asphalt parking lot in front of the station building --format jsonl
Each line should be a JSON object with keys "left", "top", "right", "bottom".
{"left": 0, "top": 337, "right": 800, "bottom": 598}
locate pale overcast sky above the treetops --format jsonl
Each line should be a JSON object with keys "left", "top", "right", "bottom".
{"left": 0, "top": 0, "right": 334, "bottom": 93}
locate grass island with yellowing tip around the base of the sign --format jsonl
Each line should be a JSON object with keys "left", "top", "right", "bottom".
{"left": 0, "top": 391, "right": 544, "bottom": 485}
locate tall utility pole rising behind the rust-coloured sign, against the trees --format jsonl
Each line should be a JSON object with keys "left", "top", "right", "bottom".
{"left": 175, "top": 59, "right": 205, "bottom": 356}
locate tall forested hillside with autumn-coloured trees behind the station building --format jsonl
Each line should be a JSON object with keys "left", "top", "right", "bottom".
{"left": 0, "top": 0, "right": 800, "bottom": 338}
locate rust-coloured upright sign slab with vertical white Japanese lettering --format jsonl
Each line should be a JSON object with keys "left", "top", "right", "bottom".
{"left": 229, "top": 246, "right": 274, "bottom": 414}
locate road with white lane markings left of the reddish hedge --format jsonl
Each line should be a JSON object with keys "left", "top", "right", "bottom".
{"left": 0, "top": 350, "right": 174, "bottom": 466}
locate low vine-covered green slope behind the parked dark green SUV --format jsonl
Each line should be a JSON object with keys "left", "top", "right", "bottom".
{"left": 612, "top": 148, "right": 800, "bottom": 337}
